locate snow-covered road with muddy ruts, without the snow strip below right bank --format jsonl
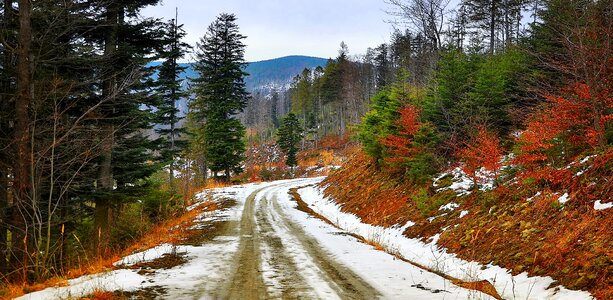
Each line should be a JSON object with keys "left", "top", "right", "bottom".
{"left": 22, "top": 178, "right": 589, "bottom": 299}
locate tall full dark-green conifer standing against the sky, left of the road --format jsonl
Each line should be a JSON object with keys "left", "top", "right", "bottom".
{"left": 190, "top": 13, "right": 249, "bottom": 180}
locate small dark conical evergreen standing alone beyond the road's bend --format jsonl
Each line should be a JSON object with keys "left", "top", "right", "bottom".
{"left": 277, "top": 113, "right": 302, "bottom": 173}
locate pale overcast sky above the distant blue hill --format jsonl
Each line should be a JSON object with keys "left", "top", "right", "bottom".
{"left": 142, "top": 0, "right": 392, "bottom": 61}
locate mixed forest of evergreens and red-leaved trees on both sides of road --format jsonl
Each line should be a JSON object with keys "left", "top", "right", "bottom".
{"left": 0, "top": 0, "right": 613, "bottom": 298}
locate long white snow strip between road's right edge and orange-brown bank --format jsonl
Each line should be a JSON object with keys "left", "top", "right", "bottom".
{"left": 298, "top": 183, "right": 592, "bottom": 299}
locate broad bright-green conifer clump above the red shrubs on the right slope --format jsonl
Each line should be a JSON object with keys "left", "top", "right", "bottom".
{"left": 422, "top": 49, "right": 528, "bottom": 147}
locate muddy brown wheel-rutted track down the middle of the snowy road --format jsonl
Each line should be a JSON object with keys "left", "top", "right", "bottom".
{"left": 219, "top": 184, "right": 380, "bottom": 299}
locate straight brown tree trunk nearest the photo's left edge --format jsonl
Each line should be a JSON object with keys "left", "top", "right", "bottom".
{"left": 11, "top": 0, "right": 32, "bottom": 279}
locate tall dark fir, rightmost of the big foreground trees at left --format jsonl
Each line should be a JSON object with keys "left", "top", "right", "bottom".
{"left": 93, "top": 0, "right": 162, "bottom": 251}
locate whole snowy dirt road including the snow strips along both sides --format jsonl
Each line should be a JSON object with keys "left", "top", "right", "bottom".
{"left": 20, "top": 178, "right": 591, "bottom": 300}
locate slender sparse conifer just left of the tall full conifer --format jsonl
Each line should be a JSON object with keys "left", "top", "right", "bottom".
{"left": 157, "top": 19, "right": 189, "bottom": 186}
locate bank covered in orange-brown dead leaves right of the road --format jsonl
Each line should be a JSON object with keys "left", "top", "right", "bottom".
{"left": 321, "top": 152, "right": 613, "bottom": 299}
